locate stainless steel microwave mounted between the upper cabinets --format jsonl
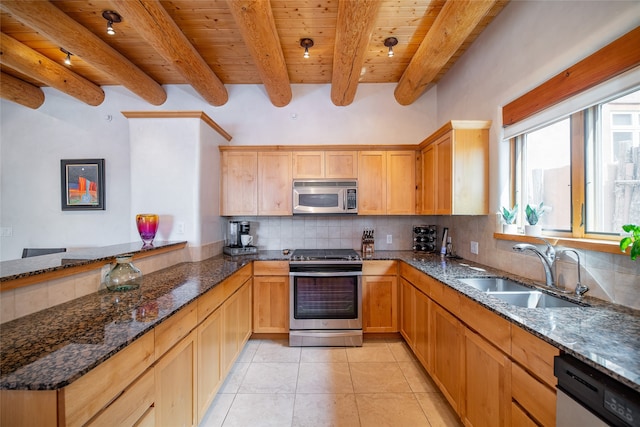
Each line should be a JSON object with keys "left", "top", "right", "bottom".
{"left": 293, "top": 179, "right": 358, "bottom": 215}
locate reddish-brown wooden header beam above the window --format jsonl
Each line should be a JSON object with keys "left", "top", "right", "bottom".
{"left": 502, "top": 27, "right": 640, "bottom": 127}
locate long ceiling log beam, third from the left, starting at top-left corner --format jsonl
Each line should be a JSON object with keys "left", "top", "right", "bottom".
{"left": 0, "top": 0, "right": 167, "bottom": 105}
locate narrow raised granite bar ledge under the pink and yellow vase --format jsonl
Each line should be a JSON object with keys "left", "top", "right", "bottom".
{"left": 0, "top": 241, "right": 187, "bottom": 282}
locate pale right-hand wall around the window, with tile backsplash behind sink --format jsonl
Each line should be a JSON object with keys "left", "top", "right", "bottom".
{"left": 438, "top": 0, "right": 640, "bottom": 308}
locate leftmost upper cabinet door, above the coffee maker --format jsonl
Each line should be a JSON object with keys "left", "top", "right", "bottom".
{"left": 220, "top": 151, "right": 258, "bottom": 215}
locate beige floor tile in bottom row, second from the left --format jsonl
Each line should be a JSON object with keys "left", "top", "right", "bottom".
{"left": 222, "top": 393, "right": 295, "bottom": 427}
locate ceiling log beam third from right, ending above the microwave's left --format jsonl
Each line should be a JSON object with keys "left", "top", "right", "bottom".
{"left": 227, "top": 0, "right": 292, "bottom": 107}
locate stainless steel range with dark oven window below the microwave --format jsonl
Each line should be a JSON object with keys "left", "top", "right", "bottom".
{"left": 289, "top": 249, "right": 362, "bottom": 347}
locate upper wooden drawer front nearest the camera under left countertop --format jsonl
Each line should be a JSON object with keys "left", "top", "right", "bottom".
{"left": 60, "top": 332, "right": 154, "bottom": 426}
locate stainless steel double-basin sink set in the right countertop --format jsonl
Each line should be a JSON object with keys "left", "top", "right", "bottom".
{"left": 458, "top": 277, "right": 584, "bottom": 308}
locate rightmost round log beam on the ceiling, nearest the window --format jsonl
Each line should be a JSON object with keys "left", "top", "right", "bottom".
{"left": 394, "top": 0, "right": 496, "bottom": 105}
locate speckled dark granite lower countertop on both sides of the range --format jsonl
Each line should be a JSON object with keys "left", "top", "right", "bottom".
{"left": 0, "top": 251, "right": 640, "bottom": 391}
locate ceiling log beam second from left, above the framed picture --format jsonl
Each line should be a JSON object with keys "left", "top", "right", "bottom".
{"left": 0, "top": 33, "right": 104, "bottom": 106}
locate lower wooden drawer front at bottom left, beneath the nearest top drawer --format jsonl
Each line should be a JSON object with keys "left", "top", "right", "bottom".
{"left": 88, "top": 369, "right": 155, "bottom": 427}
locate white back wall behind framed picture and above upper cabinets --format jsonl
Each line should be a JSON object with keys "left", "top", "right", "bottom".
{"left": 0, "top": 84, "right": 440, "bottom": 260}
